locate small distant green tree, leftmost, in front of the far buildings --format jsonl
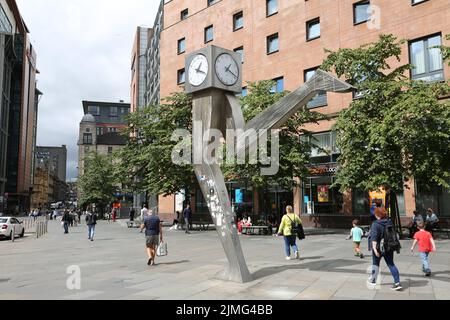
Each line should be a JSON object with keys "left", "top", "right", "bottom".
{"left": 78, "top": 153, "right": 117, "bottom": 215}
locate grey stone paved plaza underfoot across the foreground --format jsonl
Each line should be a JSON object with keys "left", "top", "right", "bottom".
{"left": 0, "top": 221, "right": 450, "bottom": 301}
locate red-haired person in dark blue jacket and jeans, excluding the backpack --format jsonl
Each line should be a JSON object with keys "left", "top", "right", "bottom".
{"left": 367, "top": 207, "right": 402, "bottom": 291}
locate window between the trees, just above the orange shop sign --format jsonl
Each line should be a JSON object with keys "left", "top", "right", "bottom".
{"left": 307, "top": 131, "right": 340, "bottom": 164}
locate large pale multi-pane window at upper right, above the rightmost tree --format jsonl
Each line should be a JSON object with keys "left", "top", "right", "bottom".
{"left": 409, "top": 35, "right": 444, "bottom": 81}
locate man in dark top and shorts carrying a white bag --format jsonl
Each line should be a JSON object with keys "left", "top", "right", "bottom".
{"left": 141, "top": 211, "right": 163, "bottom": 266}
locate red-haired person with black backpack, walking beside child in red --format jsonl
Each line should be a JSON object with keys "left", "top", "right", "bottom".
{"left": 367, "top": 207, "right": 402, "bottom": 291}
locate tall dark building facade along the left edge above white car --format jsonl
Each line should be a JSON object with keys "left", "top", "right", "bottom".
{"left": 0, "top": 0, "right": 42, "bottom": 214}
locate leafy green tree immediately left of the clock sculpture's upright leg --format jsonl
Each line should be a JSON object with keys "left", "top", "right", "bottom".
{"left": 115, "top": 92, "right": 196, "bottom": 199}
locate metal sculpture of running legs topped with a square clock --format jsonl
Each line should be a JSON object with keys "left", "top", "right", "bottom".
{"left": 185, "top": 46, "right": 354, "bottom": 283}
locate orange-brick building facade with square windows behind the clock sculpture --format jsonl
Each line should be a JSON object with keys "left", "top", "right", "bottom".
{"left": 152, "top": 0, "right": 450, "bottom": 225}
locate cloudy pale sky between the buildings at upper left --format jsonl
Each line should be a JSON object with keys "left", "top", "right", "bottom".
{"left": 16, "top": 0, "right": 159, "bottom": 180}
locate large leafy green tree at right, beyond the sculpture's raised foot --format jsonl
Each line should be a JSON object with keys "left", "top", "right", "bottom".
{"left": 322, "top": 35, "right": 450, "bottom": 198}
